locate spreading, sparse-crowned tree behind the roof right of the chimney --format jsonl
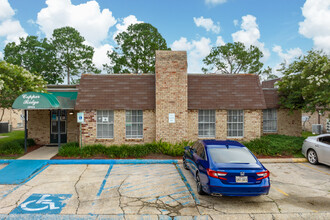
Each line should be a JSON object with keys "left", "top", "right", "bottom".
{"left": 202, "top": 42, "right": 271, "bottom": 75}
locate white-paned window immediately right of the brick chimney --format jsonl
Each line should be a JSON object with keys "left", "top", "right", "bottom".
{"left": 198, "top": 110, "right": 215, "bottom": 138}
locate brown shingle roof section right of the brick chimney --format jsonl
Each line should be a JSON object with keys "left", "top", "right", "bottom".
{"left": 188, "top": 74, "right": 266, "bottom": 110}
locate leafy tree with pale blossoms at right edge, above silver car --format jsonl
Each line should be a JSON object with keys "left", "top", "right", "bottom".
{"left": 278, "top": 50, "right": 330, "bottom": 113}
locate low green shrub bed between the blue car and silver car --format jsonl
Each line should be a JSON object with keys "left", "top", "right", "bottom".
{"left": 243, "top": 135, "right": 305, "bottom": 156}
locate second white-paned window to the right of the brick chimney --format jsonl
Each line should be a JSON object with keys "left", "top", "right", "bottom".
{"left": 227, "top": 110, "right": 244, "bottom": 137}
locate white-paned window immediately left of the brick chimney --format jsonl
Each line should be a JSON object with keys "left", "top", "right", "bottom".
{"left": 126, "top": 110, "right": 143, "bottom": 138}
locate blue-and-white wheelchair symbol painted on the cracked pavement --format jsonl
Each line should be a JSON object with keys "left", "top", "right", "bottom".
{"left": 10, "top": 194, "right": 72, "bottom": 214}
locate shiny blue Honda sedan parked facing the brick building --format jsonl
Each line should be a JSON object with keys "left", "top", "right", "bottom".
{"left": 183, "top": 140, "right": 270, "bottom": 196}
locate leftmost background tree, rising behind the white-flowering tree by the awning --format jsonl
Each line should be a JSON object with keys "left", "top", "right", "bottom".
{"left": 4, "top": 36, "right": 63, "bottom": 84}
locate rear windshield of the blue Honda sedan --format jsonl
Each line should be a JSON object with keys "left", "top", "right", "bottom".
{"left": 208, "top": 146, "right": 257, "bottom": 163}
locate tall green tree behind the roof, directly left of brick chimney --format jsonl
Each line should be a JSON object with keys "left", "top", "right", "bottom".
{"left": 104, "top": 23, "right": 170, "bottom": 73}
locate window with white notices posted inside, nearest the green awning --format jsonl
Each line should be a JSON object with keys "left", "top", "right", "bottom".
{"left": 96, "top": 110, "right": 113, "bottom": 138}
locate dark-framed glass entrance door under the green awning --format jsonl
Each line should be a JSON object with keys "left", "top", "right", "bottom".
{"left": 50, "top": 110, "right": 67, "bottom": 143}
